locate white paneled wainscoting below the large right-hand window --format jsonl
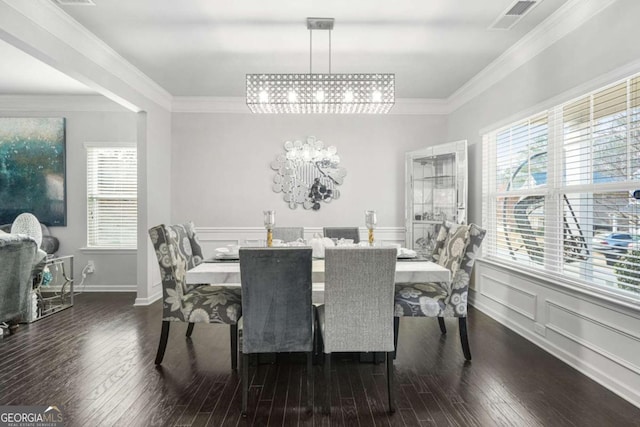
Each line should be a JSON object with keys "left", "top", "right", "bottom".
{"left": 469, "top": 259, "right": 640, "bottom": 407}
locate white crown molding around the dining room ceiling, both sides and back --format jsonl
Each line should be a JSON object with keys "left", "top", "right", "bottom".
{"left": 0, "top": 0, "right": 616, "bottom": 115}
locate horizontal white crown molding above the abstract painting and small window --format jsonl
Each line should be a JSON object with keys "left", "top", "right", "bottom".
{"left": 0, "top": 95, "right": 130, "bottom": 113}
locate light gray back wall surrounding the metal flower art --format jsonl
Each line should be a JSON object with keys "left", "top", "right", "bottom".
{"left": 171, "top": 113, "right": 446, "bottom": 227}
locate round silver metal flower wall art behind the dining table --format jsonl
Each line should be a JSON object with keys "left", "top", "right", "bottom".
{"left": 271, "top": 136, "right": 347, "bottom": 211}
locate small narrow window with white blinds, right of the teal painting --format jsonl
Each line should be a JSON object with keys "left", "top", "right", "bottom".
{"left": 86, "top": 144, "right": 138, "bottom": 249}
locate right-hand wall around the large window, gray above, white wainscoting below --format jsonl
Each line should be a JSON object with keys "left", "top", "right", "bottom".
{"left": 448, "top": 0, "right": 640, "bottom": 406}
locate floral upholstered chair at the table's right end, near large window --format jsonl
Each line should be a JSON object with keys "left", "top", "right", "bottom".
{"left": 394, "top": 224, "right": 486, "bottom": 360}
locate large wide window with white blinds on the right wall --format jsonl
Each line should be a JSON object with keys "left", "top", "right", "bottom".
{"left": 483, "top": 77, "right": 640, "bottom": 298}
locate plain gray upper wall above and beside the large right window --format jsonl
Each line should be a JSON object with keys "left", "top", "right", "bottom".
{"left": 447, "top": 0, "right": 640, "bottom": 227}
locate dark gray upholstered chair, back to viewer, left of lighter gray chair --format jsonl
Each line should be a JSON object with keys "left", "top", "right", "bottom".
{"left": 240, "top": 247, "right": 315, "bottom": 416}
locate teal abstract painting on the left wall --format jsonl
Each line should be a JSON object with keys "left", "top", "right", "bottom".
{"left": 0, "top": 117, "right": 67, "bottom": 226}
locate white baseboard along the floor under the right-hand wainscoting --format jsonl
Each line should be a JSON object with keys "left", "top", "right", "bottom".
{"left": 469, "top": 290, "right": 640, "bottom": 408}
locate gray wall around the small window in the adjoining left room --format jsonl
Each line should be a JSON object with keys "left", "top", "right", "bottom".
{"left": 0, "top": 104, "right": 136, "bottom": 291}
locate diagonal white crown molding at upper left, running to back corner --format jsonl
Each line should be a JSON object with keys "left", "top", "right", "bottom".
{"left": 3, "top": 0, "right": 172, "bottom": 110}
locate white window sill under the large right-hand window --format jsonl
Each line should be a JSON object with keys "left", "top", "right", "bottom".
{"left": 477, "top": 258, "right": 640, "bottom": 315}
